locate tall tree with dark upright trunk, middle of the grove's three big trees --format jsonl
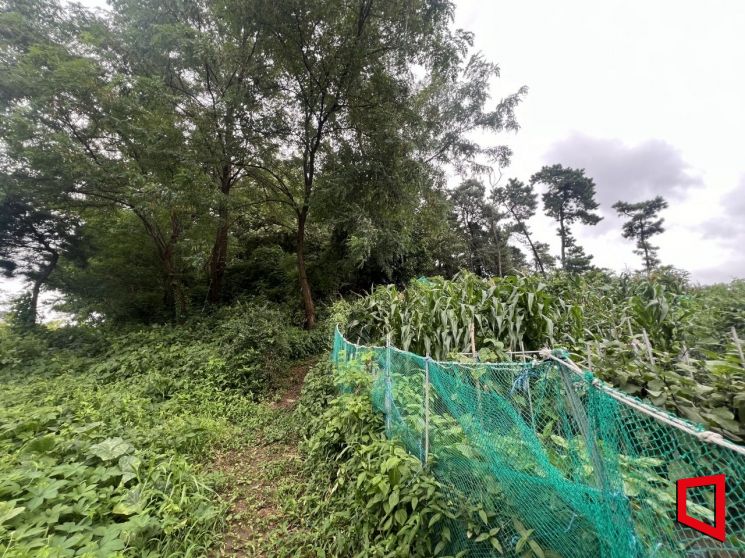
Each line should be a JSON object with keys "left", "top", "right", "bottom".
{"left": 113, "top": 0, "right": 277, "bottom": 304}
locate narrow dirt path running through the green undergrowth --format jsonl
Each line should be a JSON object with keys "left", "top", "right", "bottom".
{"left": 212, "top": 359, "right": 316, "bottom": 558}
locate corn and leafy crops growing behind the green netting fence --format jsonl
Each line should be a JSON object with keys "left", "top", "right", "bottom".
{"left": 346, "top": 271, "right": 745, "bottom": 440}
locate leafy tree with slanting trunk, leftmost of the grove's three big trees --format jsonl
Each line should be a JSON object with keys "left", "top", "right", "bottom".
{"left": 0, "top": 1, "right": 209, "bottom": 318}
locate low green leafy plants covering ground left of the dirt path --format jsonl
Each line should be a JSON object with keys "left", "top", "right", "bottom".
{"left": 0, "top": 304, "right": 320, "bottom": 558}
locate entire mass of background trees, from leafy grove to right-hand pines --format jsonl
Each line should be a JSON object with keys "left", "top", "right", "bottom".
{"left": 0, "top": 0, "right": 676, "bottom": 327}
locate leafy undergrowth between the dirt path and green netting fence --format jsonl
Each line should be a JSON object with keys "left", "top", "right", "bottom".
{"left": 273, "top": 362, "right": 506, "bottom": 558}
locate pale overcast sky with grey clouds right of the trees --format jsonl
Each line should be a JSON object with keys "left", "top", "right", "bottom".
{"left": 456, "top": 0, "right": 745, "bottom": 283}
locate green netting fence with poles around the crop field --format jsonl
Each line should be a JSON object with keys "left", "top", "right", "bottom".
{"left": 332, "top": 330, "right": 745, "bottom": 558}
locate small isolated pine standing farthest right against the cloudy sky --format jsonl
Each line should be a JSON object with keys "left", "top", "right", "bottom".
{"left": 613, "top": 196, "right": 667, "bottom": 274}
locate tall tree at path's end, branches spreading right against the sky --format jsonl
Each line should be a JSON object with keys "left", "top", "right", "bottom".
{"left": 253, "top": 0, "right": 522, "bottom": 327}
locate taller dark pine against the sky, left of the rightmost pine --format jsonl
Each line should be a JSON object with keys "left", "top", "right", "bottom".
{"left": 530, "top": 165, "right": 602, "bottom": 269}
